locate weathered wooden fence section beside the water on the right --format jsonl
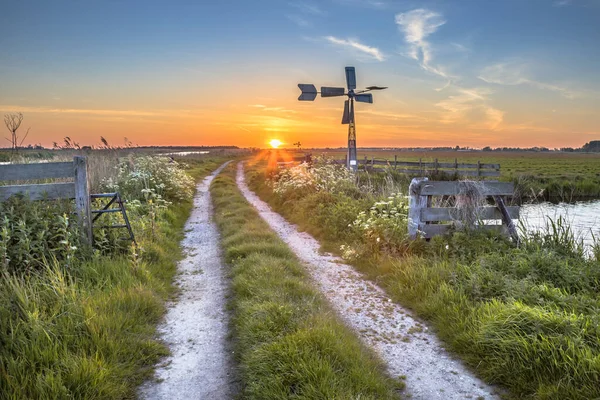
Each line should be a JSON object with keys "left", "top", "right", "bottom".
{"left": 408, "top": 178, "right": 519, "bottom": 242}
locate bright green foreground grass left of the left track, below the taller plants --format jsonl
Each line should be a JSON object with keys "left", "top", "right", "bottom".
{"left": 0, "top": 159, "right": 226, "bottom": 400}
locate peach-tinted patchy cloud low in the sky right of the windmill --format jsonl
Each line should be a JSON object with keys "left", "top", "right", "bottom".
{"left": 436, "top": 86, "right": 504, "bottom": 130}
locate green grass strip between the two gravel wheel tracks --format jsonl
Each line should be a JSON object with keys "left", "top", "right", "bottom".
{"left": 211, "top": 166, "right": 402, "bottom": 400}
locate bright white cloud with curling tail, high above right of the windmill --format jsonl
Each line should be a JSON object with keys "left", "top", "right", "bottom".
{"left": 396, "top": 8, "right": 449, "bottom": 78}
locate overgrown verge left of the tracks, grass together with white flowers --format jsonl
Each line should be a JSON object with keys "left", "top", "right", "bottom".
{"left": 0, "top": 151, "right": 229, "bottom": 399}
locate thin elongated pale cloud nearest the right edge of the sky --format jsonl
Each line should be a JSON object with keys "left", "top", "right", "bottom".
{"left": 478, "top": 62, "right": 581, "bottom": 99}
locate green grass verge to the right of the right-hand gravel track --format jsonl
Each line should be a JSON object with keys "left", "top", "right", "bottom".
{"left": 247, "top": 162, "right": 600, "bottom": 399}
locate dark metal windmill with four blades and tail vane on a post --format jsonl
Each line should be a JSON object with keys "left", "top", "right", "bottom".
{"left": 298, "top": 67, "right": 387, "bottom": 172}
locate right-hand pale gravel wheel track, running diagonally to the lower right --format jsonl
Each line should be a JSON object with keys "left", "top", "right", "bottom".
{"left": 236, "top": 163, "right": 498, "bottom": 400}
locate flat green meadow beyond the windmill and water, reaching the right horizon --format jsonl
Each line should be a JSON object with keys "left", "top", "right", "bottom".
{"left": 307, "top": 149, "right": 600, "bottom": 202}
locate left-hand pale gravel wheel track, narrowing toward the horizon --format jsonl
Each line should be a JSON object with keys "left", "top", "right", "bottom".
{"left": 140, "top": 162, "right": 235, "bottom": 400}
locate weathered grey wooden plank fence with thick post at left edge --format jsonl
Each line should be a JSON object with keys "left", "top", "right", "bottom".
{"left": 0, "top": 156, "right": 92, "bottom": 244}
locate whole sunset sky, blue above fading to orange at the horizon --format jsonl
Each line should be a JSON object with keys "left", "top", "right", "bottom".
{"left": 0, "top": 0, "right": 600, "bottom": 148}
